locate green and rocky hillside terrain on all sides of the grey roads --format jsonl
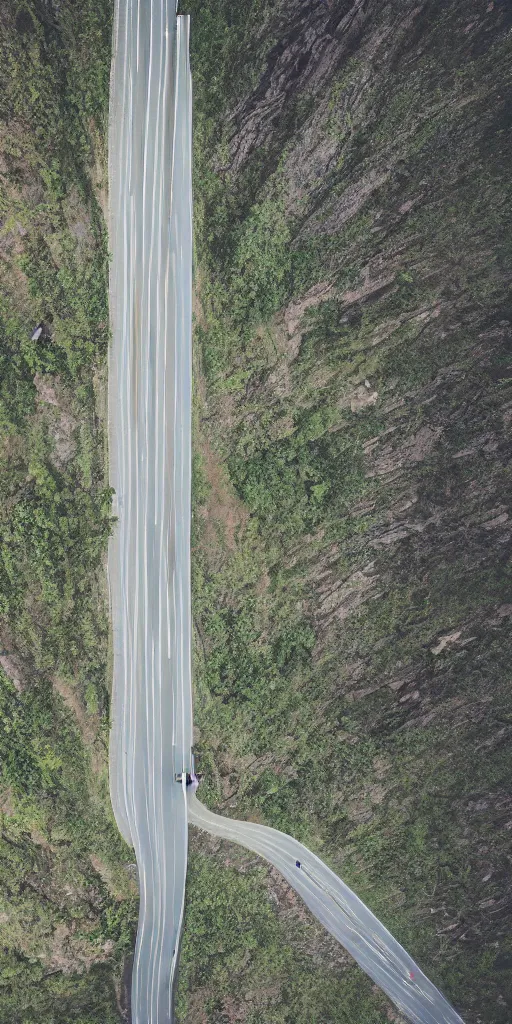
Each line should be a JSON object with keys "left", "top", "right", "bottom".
{"left": 4, "top": 0, "right": 512, "bottom": 1024}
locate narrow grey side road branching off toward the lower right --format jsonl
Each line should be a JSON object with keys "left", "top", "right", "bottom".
{"left": 188, "top": 793, "right": 463, "bottom": 1024}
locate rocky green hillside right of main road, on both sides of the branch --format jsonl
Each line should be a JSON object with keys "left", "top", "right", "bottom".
{"left": 180, "top": 0, "right": 512, "bottom": 1024}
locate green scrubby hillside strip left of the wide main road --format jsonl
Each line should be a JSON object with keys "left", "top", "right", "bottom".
{"left": 0, "top": 0, "right": 137, "bottom": 1024}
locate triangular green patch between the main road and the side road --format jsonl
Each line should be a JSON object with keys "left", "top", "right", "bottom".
{"left": 176, "top": 844, "right": 387, "bottom": 1024}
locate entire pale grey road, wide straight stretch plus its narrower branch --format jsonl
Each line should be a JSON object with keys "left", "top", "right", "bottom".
{"left": 109, "top": 0, "right": 468, "bottom": 1024}
